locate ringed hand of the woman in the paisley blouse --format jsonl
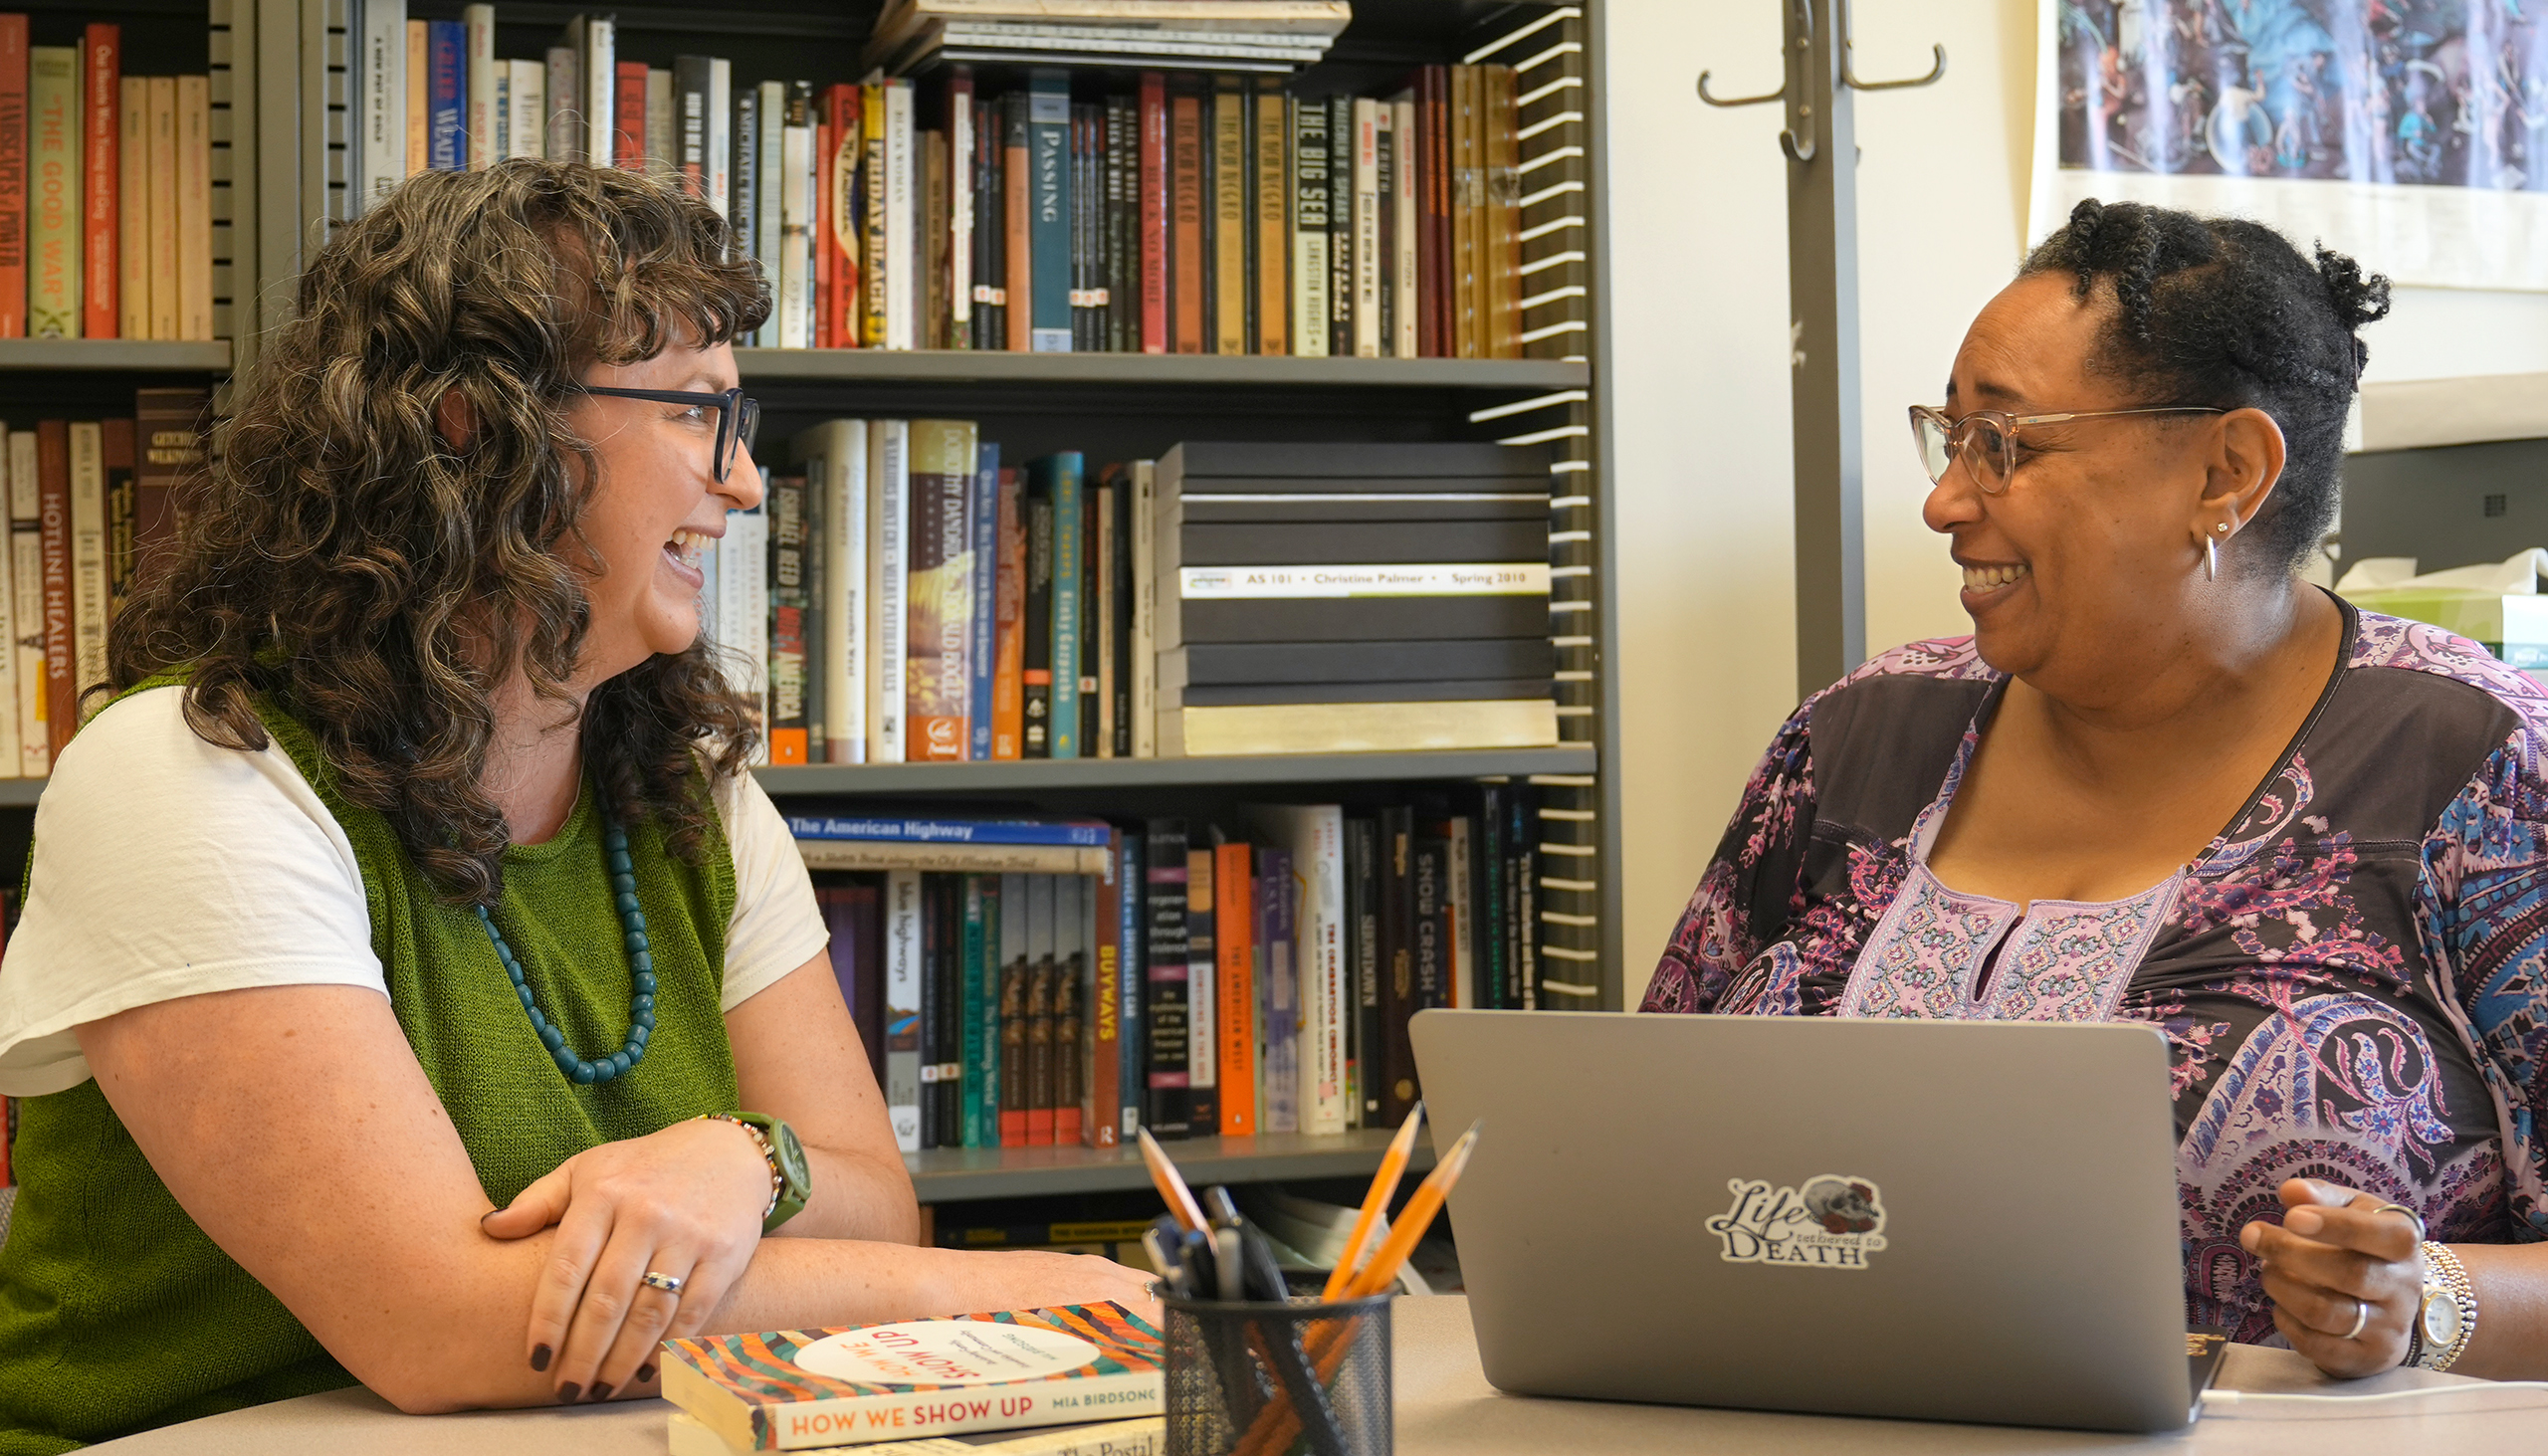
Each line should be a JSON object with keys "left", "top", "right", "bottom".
{"left": 2239, "top": 1178, "right": 2424, "bottom": 1377}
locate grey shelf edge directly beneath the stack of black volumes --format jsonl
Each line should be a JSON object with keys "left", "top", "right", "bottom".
{"left": 751, "top": 744, "right": 1600, "bottom": 795}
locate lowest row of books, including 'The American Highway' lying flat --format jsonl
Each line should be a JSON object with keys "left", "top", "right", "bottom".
{"left": 790, "top": 780, "right": 1597, "bottom": 1152}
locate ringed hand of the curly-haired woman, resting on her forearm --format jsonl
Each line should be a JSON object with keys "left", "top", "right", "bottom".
{"left": 479, "top": 1120, "right": 769, "bottom": 1400}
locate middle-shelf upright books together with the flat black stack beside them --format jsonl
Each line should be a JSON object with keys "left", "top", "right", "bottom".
{"left": 704, "top": 421, "right": 1557, "bottom": 765}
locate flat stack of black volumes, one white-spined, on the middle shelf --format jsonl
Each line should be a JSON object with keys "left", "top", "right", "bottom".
{"left": 1152, "top": 441, "right": 1557, "bottom": 757}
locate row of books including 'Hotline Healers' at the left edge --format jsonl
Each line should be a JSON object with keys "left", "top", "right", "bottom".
{"left": 0, "top": 390, "right": 211, "bottom": 777}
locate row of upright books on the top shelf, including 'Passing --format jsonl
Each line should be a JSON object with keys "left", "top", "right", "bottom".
{"left": 356, "top": 3, "right": 1590, "bottom": 357}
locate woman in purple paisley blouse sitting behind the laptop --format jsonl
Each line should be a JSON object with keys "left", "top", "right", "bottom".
{"left": 1643, "top": 201, "right": 2548, "bottom": 1377}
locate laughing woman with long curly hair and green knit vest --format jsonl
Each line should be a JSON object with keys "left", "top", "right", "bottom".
{"left": 0, "top": 160, "right": 1147, "bottom": 1451}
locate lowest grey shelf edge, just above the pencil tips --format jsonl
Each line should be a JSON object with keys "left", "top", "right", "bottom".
{"left": 902, "top": 1127, "right": 1432, "bottom": 1203}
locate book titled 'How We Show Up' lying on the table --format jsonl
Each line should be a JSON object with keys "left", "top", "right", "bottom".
{"left": 663, "top": 1303, "right": 1165, "bottom": 1451}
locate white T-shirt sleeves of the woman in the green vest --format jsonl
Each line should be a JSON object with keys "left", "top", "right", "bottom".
{"left": 0, "top": 689, "right": 828, "bottom": 1097}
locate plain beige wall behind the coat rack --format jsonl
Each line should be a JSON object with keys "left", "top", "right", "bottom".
{"left": 1602, "top": 0, "right": 2548, "bottom": 1004}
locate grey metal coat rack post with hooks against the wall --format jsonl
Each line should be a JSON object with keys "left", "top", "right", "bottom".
{"left": 1700, "top": 0, "right": 1947, "bottom": 696}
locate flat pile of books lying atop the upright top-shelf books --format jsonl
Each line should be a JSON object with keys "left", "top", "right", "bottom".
{"left": 861, "top": 0, "right": 1353, "bottom": 77}
